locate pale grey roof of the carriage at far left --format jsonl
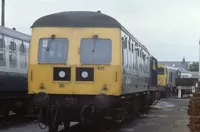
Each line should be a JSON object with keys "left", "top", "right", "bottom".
{"left": 0, "top": 26, "right": 30, "bottom": 42}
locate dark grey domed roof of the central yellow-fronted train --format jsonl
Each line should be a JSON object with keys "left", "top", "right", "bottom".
{"left": 31, "top": 11, "right": 149, "bottom": 53}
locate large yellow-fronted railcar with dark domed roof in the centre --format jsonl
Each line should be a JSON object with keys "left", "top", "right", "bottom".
{"left": 28, "top": 11, "right": 157, "bottom": 131}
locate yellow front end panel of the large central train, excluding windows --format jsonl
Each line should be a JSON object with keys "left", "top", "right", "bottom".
{"left": 28, "top": 27, "right": 122, "bottom": 95}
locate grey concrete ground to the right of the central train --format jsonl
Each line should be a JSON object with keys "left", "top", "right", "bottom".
{"left": 118, "top": 98, "right": 189, "bottom": 132}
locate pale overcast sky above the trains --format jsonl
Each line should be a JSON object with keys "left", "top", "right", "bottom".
{"left": 1, "top": 0, "right": 200, "bottom": 61}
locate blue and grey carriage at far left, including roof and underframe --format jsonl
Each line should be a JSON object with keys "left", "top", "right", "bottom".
{"left": 0, "top": 26, "right": 31, "bottom": 116}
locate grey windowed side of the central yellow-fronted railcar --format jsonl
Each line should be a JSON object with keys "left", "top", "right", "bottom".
{"left": 121, "top": 31, "right": 150, "bottom": 94}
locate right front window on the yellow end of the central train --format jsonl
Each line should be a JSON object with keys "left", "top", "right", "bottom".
{"left": 80, "top": 38, "right": 112, "bottom": 64}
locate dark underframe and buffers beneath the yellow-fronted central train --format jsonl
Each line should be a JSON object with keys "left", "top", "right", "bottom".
{"left": 34, "top": 91, "right": 159, "bottom": 132}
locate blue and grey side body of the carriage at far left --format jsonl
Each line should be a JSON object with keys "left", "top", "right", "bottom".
{"left": 0, "top": 27, "right": 29, "bottom": 93}
